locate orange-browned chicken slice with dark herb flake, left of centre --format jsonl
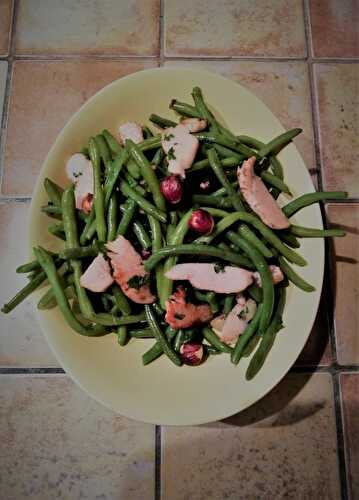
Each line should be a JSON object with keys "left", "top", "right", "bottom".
{"left": 106, "top": 236, "right": 156, "bottom": 304}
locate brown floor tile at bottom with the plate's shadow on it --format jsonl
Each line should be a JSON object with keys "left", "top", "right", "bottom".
{"left": 162, "top": 374, "right": 340, "bottom": 500}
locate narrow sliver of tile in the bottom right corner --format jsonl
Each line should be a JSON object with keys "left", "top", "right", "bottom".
{"left": 340, "top": 373, "right": 359, "bottom": 500}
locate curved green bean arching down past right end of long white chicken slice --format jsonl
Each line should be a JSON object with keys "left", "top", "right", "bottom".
{"left": 227, "top": 231, "right": 274, "bottom": 332}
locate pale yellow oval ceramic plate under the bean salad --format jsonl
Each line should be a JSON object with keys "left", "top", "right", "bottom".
{"left": 29, "top": 68, "right": 324, "bottom": 425}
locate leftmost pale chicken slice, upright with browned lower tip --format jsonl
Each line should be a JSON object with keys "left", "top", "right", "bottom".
{"left": 66, "top": 153, "right": 94, "bottom": 213}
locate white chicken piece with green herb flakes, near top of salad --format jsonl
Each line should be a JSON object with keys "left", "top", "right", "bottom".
{"left": 162, "top": 124, "right": 198, "bottom": 179}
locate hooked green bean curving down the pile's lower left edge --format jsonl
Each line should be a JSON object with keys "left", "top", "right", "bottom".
{"left": 34, "top": 247, "right": 109, "bottom": 337}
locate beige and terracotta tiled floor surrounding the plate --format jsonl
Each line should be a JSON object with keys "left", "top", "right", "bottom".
{"left": 0, "top": 0, "right": 359, "bottom": 500}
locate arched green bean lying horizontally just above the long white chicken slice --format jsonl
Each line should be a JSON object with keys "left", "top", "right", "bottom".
{"left": 145, "top": 240, "right": 253, "bottom": 272}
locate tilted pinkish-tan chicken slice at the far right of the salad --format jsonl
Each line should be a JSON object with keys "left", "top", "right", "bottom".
{"left": 237, "top": 156, "right": 290, "bottom": 229}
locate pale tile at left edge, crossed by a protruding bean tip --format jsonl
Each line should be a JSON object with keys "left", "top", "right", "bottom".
{"left": 0, "top": 202, "right": 58, "bottom": 367}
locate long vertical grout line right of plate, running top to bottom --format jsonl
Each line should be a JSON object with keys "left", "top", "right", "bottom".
{"left": 303, "top": 0, "right": 348, "bottom": 499}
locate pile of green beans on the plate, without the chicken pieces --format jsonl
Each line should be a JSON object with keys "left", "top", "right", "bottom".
{"left": 1, "top": 87, "right": 347, "bottom": 380}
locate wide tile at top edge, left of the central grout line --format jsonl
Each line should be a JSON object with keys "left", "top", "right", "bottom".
{"left": 15, "top": 0, "right": 160, "bottom": 56}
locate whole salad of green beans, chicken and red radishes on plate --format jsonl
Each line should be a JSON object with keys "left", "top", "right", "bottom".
{"left": 2, "top": 87, "right": 347, "bottom": 380}
